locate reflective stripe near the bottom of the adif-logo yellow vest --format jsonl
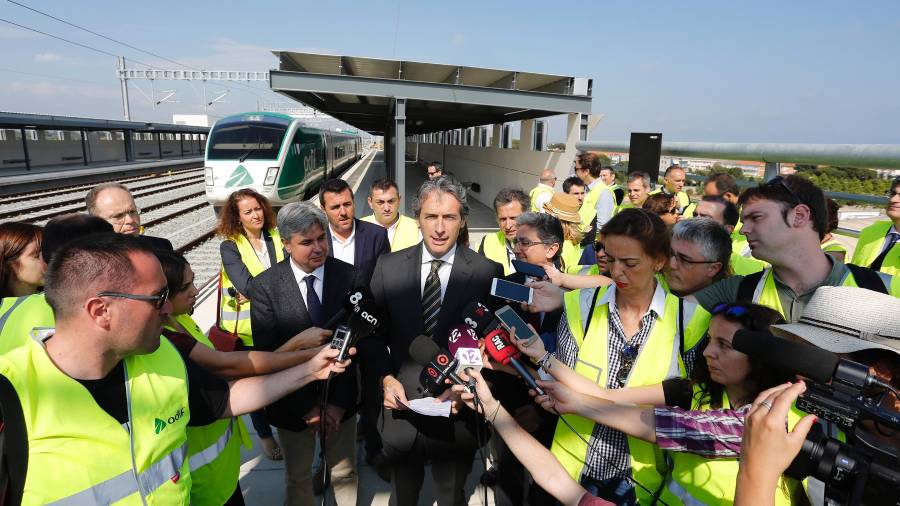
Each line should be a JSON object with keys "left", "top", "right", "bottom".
{"left": 49, "top": 443, "right": 187, "bottom": 506}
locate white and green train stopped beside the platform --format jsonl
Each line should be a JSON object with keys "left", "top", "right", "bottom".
{"left": 204, "top": 112, "right": 362, "bottom": 211}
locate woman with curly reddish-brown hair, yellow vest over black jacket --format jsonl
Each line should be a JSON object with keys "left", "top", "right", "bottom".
{"left": 216, "top": 188, "right": 284, "bottom": 460}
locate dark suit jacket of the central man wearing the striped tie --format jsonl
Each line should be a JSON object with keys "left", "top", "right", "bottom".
{"left": 360, "top": 240, "right": 503, "bottom": 442}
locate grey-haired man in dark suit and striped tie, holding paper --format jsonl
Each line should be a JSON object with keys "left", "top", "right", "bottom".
{"left": 360, "top": 177, "right": 503, "bottom": 506}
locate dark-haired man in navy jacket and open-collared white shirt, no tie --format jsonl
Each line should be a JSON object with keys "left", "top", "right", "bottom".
{"left": 319, "top": 179, "right": 391, "bottom": 281}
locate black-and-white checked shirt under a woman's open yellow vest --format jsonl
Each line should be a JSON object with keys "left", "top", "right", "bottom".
{"left": 556, "top": 285, "right": 666, "bottom": 480}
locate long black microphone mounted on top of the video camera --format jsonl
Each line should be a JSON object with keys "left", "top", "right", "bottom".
{"left": 731, "top": 329, "right": 891, "bottom": 389}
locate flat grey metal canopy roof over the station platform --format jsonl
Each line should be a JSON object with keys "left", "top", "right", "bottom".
{"left": 269, "top": 51, "right": 591, "bottom": 135}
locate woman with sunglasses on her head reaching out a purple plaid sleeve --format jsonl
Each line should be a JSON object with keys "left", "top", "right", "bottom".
{"left": 523, "top": 304, "right": 801, "bottom": 505}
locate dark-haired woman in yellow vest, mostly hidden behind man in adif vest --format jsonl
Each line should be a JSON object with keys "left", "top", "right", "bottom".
{"left": 156, "top": 251, "right": 331, "bottom": 506}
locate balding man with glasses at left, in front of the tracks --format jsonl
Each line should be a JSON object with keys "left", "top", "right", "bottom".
{"left": 84, "top": 183, "right": 172, "bottom": 251}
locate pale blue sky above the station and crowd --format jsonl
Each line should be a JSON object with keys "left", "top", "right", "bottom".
{"left": 0, "top": 0, "right": 900, "bottom": 143}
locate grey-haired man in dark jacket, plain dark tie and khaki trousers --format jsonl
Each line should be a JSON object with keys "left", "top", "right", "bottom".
{"left": 250, "top": 202, "right": 365, "bottom": 506}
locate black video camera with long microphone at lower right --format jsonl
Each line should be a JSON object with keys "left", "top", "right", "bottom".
{"left": 732, "top": 330, "right": 900, "bottom": 505}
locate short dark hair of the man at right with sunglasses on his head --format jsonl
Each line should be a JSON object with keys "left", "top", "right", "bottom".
{"left": 738, "top": 174, "right": 828, "bottom": 240}
